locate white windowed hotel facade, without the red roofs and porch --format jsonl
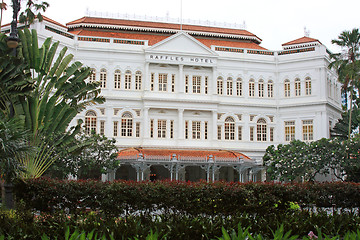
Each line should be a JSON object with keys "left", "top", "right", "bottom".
{"left": 1, "top": 17, "right": 341, "bottom": 180}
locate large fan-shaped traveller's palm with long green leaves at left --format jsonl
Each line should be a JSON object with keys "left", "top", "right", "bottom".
{"left": 0, "top": 29, "right": 104, "bottom": 177}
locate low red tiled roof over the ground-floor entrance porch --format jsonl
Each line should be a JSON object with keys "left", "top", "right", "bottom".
{"left": 118, "top": 148, "right": 250, "bottom": 160}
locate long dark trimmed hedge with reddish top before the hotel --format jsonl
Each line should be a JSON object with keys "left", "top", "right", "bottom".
{"left": 15, "top": 178, "right": 360, "bottom": 216}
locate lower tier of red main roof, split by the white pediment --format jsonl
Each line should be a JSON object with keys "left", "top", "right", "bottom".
{"left": 69, "top": 29, "right": 266, "bottom": 50}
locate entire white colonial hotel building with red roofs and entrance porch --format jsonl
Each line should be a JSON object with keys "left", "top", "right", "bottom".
{"left": 3, "top": 17, "right": 341, "bottom": 181}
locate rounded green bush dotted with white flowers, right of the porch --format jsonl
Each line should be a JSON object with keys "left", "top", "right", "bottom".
{"left": 263, "top": 138, "right": 360, "bottom": 181}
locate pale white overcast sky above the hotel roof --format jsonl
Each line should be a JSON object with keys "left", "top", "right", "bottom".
{"left": 3, "top": 0, "right": 360, "bottom": 52}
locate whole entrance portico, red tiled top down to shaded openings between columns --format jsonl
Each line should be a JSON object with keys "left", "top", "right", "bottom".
{"left": 116, "top": 148, "right": 263, "bottom": 182}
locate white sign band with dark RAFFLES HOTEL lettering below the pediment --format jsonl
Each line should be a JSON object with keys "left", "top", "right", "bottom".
{"left": 146, "top": 54, "right": 217, "bottom": 66}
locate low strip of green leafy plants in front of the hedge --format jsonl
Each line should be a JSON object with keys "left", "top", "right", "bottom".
{"left": 0, "top": 209, "right": 360, "bottom": 240}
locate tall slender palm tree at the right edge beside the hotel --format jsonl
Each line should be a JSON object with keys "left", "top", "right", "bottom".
{"left": 329, "top": 29, "right": 360, "bottom": 138}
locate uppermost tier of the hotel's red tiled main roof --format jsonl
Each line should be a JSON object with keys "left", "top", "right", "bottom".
{"left": 66, "top": 17, "right": 261, "bottom": 41}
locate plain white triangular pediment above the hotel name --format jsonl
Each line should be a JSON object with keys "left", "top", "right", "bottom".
{"left": 146, "top": 32, "right": 217, "bottom": 56}
